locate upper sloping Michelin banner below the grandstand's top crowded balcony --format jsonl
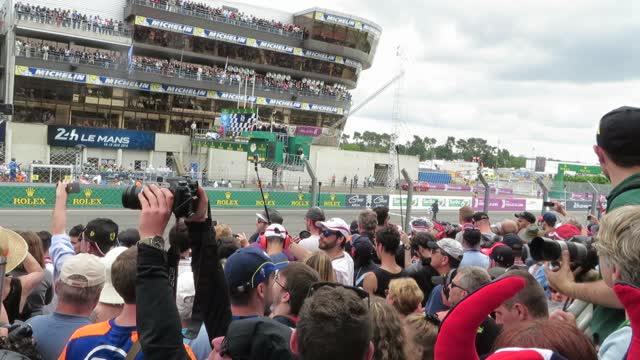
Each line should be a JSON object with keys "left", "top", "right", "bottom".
{"left": 135, "top": 16, "right": 362, "bottom": 71}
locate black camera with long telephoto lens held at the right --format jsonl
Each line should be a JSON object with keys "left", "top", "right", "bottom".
{"left": 529, "top": 236, "right": 598, "bottom": 278}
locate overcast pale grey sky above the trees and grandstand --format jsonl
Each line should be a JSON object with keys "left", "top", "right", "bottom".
{"left": 268, "top": 0, "right": 640, "bottom": 163}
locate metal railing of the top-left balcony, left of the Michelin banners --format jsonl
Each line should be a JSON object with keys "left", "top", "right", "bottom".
{"left": 16, "top": 9, "right": 131, "bottom": 38}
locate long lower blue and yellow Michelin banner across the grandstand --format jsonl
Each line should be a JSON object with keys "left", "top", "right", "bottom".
{"left": 15, "top": 65, "right": 345, "bottom": 115}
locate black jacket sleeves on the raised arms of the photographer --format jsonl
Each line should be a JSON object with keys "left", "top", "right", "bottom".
{"left": 136, "top": 221, "right": 231, "bottom": 360}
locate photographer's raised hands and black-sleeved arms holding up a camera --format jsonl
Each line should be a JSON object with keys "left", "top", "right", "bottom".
{"left": 136, "top": 185, "right": 231, "bottom": 359}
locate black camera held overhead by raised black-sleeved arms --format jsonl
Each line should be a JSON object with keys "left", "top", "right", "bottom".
{"left": 122, "top": 177, "right": 198, "bottom": 218}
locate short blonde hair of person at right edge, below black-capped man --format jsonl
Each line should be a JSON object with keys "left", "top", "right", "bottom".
{"left": 596, "top": 205, "right": 640, "bottom": 286}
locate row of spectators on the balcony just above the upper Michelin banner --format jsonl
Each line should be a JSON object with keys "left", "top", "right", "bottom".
{"left": 147, "top": 0, "right": 302, "bottom": 35}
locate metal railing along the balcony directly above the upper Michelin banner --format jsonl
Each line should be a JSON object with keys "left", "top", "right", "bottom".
{"left": 131, "top": 0, "right": 304, "bottom": 40}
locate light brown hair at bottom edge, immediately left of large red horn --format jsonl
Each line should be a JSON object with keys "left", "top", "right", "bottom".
{"left": 404, "top": 314, "right": 440, "bottom": 360}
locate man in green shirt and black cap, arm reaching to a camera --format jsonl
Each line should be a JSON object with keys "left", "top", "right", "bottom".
{"left": 545, "top": 106, "right": 640, "bottom": 344}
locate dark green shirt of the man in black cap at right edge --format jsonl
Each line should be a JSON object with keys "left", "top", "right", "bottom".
{"left": 591, "top": 173, "right": 640, "bottom": 344}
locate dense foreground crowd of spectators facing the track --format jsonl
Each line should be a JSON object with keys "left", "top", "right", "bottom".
{"left": 0, "top": 107, "right": 640, "bottom": 360}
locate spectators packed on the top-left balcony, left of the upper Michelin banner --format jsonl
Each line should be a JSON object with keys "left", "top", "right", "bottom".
{"left": 14, "top": 2, "right": 126, "bottom": 35}
